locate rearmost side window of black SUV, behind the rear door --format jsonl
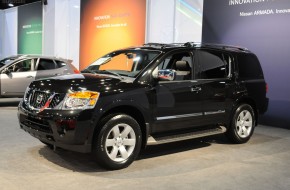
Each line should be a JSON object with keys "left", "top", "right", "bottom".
{"left": 238, "top": 54, "right": 263, "bottom": 78}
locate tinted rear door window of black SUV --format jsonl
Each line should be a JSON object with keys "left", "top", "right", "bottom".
{"left": 199, "top": 50, "right": 232, "bottom": 79}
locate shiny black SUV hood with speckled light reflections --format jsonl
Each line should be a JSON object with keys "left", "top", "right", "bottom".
{"left": 29, "top": 74, "right": 134, "bottom": 93}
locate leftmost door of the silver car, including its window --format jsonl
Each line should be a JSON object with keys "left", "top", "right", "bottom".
{"left": 1, "top": 59, "right": 36, "bottom": 97}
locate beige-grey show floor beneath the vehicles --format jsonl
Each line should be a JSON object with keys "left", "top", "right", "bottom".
{"left": 0, "top": 99, "right": 290, "bottom": 190}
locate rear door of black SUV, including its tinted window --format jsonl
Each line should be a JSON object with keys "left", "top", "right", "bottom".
{"left": 196, "top": 49, "right": 234, "bottom": 125}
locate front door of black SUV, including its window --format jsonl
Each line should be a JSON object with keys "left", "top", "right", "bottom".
{"left": 152, "top": 52, "right": 203, "bottom": 133}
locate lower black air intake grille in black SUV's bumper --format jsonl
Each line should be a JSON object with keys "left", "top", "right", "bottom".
{"left": 21, "top": 117, "right": 52, "bottom": 133}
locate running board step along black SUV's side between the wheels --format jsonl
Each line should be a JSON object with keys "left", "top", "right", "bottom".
{"left": 147, "top": 126, "right": 227, "bottom": 145}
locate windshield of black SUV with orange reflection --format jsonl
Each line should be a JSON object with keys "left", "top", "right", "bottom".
{"left": 82, "top": 50, "right": 160, "bottom": 78}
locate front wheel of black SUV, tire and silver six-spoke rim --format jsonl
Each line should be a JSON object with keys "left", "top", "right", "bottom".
{"left": 92, "top": 114, "right": 142, "bottom": 170}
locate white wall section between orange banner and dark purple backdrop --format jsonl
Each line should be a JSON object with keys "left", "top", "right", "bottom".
{"left": 146, "top": 0, "right": 203, "bottom": 43}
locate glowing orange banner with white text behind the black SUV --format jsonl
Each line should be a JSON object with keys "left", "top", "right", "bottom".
{"left": 80, "top": 0, "right": 146, "bottom": 70}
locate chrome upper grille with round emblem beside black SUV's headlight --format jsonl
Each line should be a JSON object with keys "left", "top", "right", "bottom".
{"left": 24, "top": 89, "right": 64, "bottom": 109}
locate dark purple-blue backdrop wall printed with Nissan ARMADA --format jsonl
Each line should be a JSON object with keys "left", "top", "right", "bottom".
{"left": 202, "top": 0, "right": 290, "bottom": 128}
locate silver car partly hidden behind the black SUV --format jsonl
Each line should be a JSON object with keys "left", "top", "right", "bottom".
{"left": 0, "top": 55, "right": 79, "bottom": 97}
